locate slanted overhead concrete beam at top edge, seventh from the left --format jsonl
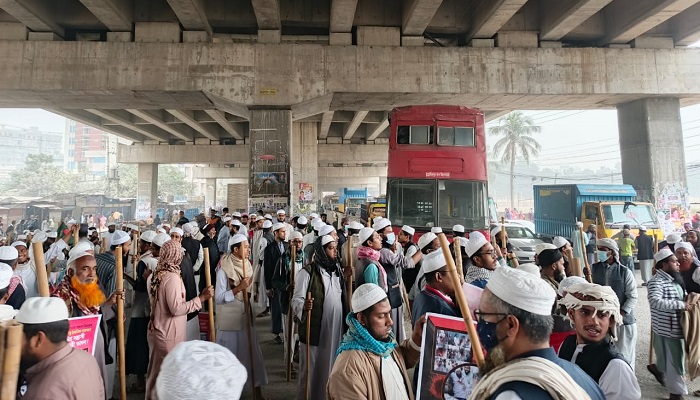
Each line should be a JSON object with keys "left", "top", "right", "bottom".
{"left": 467, "top": 0, "right": 527, "bottom": 41}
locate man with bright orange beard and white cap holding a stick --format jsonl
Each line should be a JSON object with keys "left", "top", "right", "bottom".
{"left": 52, "top": 242, "right": 123, "bottom": 395}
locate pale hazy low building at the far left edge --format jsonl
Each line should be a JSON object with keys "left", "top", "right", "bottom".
{"left": 0, "top": 125, "right": 63, "bottom": 179}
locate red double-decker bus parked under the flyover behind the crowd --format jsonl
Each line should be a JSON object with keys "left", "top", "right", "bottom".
{"left": 386, "top": 105, "right": 489, "bottom": 233}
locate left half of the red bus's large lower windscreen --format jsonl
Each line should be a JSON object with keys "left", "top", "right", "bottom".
{"left": 387, "top": 179, "right": 435, "bottom": 226}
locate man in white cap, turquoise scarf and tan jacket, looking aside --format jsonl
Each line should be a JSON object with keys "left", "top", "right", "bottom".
{"left": 325, "top": 283, "right": 425, "bottom": 400}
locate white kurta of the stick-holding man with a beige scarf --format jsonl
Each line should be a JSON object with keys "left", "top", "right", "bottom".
{"left": 214, "top": 269, "right": 267, "bottom": 389}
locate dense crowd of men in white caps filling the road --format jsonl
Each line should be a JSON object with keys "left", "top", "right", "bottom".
{"left": 0, "top": 208, "right": 700, "bottom": 400}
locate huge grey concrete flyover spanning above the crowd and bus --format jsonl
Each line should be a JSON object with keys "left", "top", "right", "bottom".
{"left": 0, "top": 0, "right": 700, "bottom": 217}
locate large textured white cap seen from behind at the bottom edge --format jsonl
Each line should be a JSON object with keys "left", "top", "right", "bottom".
{"left": 156, "top": 340, "right": 248, "bottom": 400}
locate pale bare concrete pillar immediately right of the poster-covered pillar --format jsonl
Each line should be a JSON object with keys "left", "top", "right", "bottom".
{"left": 290, "top": 122, "right": 321, "bottom": 214}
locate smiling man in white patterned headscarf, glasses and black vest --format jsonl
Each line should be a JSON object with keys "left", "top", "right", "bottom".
{"left": 559, "top": 282, "right": 642, "bottom": 400}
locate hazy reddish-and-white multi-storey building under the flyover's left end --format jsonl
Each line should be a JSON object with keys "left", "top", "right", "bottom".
{"left": 64, "top": 120, "right": 117, "bottom": 177}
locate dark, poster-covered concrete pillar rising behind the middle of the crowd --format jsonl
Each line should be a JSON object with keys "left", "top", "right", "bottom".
{"left": 248, "top": 110, "right": 292, "bottom": 213}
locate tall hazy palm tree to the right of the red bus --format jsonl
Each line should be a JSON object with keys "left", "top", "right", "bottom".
{"left": 490, "top": 111, "right": 541, "bottom": 208}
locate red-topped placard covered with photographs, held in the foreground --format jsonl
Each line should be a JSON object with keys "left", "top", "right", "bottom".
{"left": 416, "top": 313, "right": 479, "bottom": 400}
